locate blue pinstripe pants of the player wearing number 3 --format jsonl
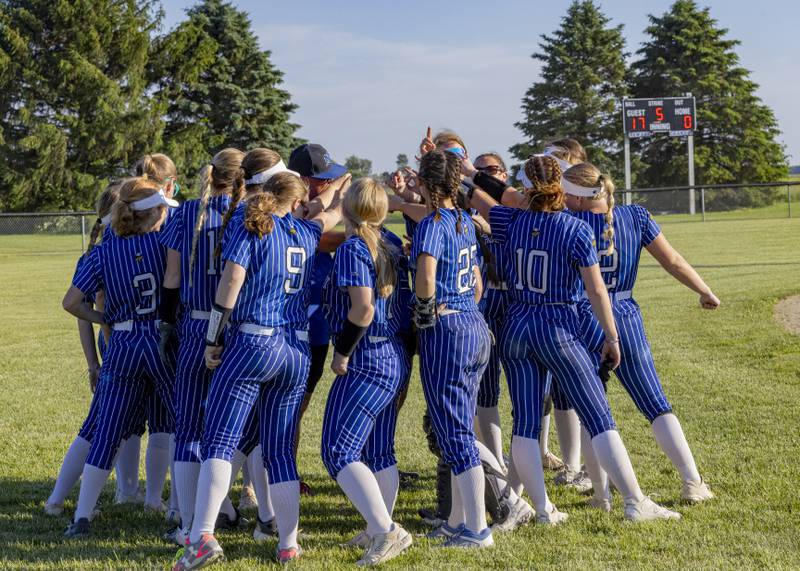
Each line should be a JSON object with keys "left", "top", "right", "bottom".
{"left": 86, "top": 328, "right": 174, "bottom": 470}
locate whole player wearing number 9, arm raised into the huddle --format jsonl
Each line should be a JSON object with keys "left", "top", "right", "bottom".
{"left": 174, "top": 149, "right": 340, "bottom": 571}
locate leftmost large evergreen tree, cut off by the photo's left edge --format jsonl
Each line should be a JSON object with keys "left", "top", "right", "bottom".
{"left": 0, "top": 0, "right": 162, "bottom": 210}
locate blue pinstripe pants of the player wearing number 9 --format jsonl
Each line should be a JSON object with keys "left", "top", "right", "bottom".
{"left": 201, "top": 328, "right": 310, "bottom": 484}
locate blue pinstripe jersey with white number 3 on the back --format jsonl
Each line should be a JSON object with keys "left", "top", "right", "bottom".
{"left": 72, "top": 232, "right": 167, "bottom": 324}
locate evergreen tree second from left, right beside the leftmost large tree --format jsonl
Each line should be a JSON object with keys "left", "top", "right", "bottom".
{"left": 152, "top": 0, "right": 302, "bottom": 190}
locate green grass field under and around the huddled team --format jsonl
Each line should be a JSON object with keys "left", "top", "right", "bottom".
{"left": 0, "top": 211, "right": 800, "bottom": 571}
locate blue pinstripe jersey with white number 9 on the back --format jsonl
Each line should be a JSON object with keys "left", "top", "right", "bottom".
{"left": 222, "top": 209, "right": 322, "bottom": 329}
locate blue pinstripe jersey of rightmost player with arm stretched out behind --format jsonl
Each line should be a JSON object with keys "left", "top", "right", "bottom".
{"left": 570, "top": 204, "right": 661, "bottom": 291}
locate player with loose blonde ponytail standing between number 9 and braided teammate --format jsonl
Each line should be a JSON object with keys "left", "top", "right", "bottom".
{"left": 322, "top": 178, "right": 412, "bottom": 565}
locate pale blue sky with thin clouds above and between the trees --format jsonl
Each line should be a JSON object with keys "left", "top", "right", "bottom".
{"left": 163, "top": 0, "right": 800, "bottom": 171}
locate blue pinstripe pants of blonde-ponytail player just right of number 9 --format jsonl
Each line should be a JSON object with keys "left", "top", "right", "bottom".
{"left": 322, "top": 337, "right": 407, "bottom": 478}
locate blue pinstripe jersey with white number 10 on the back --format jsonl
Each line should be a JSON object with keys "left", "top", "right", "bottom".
{"left": 489, "top": 206, "right": 597, "bottom": 305}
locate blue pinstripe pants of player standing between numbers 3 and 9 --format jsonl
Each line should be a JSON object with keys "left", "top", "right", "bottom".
{"left": 175, "top": 318, "right": 212, "bottom": 463}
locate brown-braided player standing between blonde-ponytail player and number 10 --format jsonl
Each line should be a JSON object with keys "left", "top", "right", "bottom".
{"left": 411, "top": 150, "right": 494, "bottom": 547}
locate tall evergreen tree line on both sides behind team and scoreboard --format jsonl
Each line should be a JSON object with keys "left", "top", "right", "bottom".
{"left": 0, "top": 0, "right": 788, "bottom": 211}
